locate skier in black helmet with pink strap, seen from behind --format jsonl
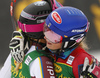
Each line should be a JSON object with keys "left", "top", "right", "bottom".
{"left": 0, "top": 0, "right": 61, "bottom": 78}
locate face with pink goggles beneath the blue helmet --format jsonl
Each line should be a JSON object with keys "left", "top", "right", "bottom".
{"left": 44, "top": 24, "right": 62, "bottom": 50}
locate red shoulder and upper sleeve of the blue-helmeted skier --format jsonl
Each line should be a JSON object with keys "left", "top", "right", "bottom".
{"left": 68, "top": 47, "right": 92, "bottom": 78}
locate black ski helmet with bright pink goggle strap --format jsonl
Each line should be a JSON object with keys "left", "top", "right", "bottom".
{"left": 18, "top": 1, "right": 52, "bottom": 39}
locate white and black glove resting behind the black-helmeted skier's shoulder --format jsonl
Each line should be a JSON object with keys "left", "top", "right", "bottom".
{"left": 9, "top": 31, "right": 29, "bottom": 63}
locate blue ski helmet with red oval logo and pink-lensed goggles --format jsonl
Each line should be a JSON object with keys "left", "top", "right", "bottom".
{"left": 44, "top": 6, "right": 89, "bottom": 50}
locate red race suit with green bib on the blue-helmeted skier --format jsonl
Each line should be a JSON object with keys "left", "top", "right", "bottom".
{"left": 52, "top": 47, "right": 93, "bottom": 78}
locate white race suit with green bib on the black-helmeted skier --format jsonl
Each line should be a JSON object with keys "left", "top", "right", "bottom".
{"left": 0, "top": 46, "right": 55, "bottom": 78}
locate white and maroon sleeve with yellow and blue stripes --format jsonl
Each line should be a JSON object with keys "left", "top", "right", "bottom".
{"left": 30, "top": 56, "right": 56, "bottom": 78}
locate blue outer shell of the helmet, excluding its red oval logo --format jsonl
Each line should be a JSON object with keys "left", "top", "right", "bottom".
{"left": 46, "top": 7, "right": 88, "bottom": 38}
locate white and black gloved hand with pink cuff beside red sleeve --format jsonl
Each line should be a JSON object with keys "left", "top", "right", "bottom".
{"left": 80, "top": 57, "right": 100, "bottom": 78}
